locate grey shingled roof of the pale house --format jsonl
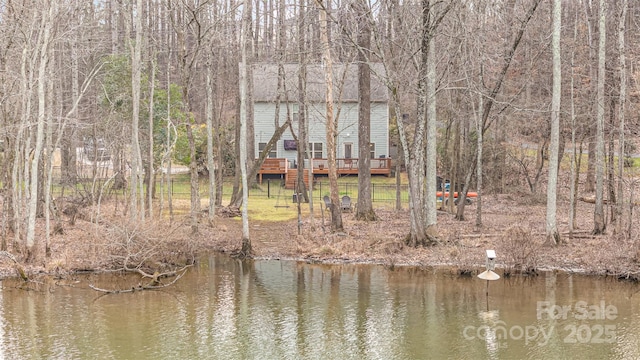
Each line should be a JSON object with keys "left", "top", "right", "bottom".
{"left": 251, "top": 63, "right": 389, "bottom": 102}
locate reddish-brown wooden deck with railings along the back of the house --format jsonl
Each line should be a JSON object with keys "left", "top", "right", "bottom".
{"left": 258, "top": 158, "right": 391, "bottom": 185}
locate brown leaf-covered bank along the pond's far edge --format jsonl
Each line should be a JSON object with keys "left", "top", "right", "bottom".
{"left": 5, "top": 191, "right": 640, "bottom": 279}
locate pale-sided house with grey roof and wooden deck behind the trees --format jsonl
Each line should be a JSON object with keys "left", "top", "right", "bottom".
{"left": 252, "top": 64, "right": 391, "bottom": 188}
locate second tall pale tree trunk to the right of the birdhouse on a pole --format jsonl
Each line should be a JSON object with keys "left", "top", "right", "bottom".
{"left": 593, "top": 0, "right": 607, "bottom": 234}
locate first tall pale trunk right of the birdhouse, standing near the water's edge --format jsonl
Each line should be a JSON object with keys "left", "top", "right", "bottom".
{"left": 546, "top": 0, "right": 562, "bottom": 245}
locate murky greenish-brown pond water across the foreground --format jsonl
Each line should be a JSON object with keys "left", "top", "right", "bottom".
{"left": 0, "top": 256, "right": 640, "bottom": 359}
